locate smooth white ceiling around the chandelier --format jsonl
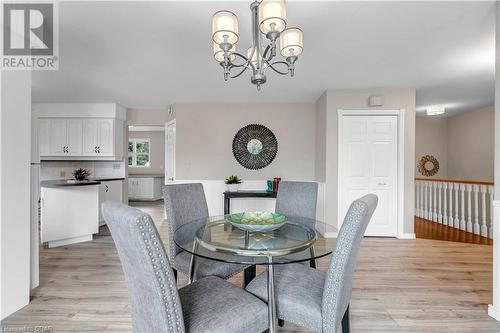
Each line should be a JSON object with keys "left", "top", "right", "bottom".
{"left": 33, "top": 1, "right": 495, "bottom": 114}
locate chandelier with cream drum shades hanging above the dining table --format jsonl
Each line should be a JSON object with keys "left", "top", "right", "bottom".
{"left": 212, "top": 0, "right": 304, "bottom": 90}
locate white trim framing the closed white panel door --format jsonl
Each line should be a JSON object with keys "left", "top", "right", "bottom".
{"left": 337, "top": 109, "right": 406, "bottom": 239}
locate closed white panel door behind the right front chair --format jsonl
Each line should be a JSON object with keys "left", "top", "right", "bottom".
{"left": 339, "top": 116, "right": 398, "bottom": 236}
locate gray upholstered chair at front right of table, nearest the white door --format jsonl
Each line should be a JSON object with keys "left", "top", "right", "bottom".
{"left": 246, "top": 194, "right": 378, "bottom": 333}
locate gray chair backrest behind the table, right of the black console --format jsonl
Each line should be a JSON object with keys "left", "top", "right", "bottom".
{"left": 275, "top": 181, "right": 318, "bottom": 219}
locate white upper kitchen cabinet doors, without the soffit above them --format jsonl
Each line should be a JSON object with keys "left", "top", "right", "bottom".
{"left": 38, "top": 118, "right": 124, "bottom": 160}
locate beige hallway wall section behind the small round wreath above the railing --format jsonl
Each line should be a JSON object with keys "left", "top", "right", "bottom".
{"left": 415, "top": 116, "right": 448, "bottom": 178}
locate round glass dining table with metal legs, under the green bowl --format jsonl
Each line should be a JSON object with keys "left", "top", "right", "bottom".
{"left": 173, "top": 215, "right": 337, "bottom": 333}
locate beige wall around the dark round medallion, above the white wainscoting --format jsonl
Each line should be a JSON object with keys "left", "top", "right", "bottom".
{"left": 176, "top": 103, "right": 315, "bottom": 180}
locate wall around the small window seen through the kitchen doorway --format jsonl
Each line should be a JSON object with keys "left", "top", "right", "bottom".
{"left": 127, "top": 131, "right": 165, "bottom": 175}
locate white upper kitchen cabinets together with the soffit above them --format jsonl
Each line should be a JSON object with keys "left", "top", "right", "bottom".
{"left": 33, "top": 103, "right": 125, "bottom": 160}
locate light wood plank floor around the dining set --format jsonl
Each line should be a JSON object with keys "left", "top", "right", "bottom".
{"left": 2, "top": 203, "right": 500, "bottom": 333}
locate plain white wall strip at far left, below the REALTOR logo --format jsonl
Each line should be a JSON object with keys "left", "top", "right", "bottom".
{"left": 0, "top": 71, "right": 31, "bottom": 319}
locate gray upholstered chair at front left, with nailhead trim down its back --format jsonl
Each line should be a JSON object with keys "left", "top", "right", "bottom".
{"left": 102, "top": 201, "right": 268, "bottom": 333}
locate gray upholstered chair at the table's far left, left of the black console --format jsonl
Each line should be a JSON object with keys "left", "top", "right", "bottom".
{"left": 163, "top": 183, "right": 246, "bottom": 280}
